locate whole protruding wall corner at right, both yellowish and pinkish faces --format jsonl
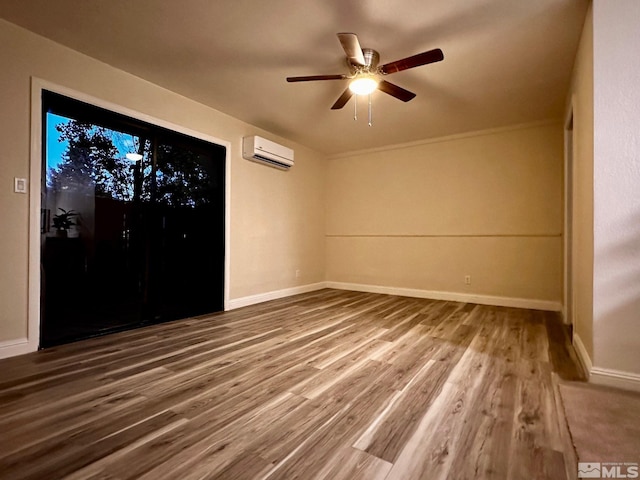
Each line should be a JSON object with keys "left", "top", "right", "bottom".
{"left": 570, "top": 0, "right": 640, "bottom": 390}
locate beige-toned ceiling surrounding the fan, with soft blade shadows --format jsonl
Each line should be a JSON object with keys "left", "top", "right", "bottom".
{"left": 0, "top": 0, "right": 588, "bottom": 154}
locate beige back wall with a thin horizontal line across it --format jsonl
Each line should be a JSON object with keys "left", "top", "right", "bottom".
{"left": 327, "top": 123, "right": 563, "bottom": 302}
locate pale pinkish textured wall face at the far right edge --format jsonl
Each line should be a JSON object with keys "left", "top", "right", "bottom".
{"left": 592, "top": 0, "right": 640, "bottom": 380}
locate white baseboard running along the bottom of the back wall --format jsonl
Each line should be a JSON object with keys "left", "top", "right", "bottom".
{"left": 326, "top": 282, "right": 562, "bottom": 312}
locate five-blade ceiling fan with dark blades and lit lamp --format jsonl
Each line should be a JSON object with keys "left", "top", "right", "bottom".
{"left": 287, "top": 33, "right": 444, "bottom": 110}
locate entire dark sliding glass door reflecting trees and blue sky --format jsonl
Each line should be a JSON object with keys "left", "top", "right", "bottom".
{"left": 40, "top": 90, "right": 226, "bottom": 347}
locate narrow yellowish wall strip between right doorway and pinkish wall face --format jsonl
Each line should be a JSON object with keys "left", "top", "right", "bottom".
{"left": 568, "top": 7, "right": 593, "bottom": 358}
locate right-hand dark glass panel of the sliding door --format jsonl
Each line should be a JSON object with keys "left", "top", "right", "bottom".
{"left": 155, "top": 137, "right": 224, "bottom": 318}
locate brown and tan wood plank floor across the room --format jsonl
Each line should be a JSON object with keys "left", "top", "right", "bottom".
{"left": 0, "top": 290, "right": 579, "bottom": 480}
